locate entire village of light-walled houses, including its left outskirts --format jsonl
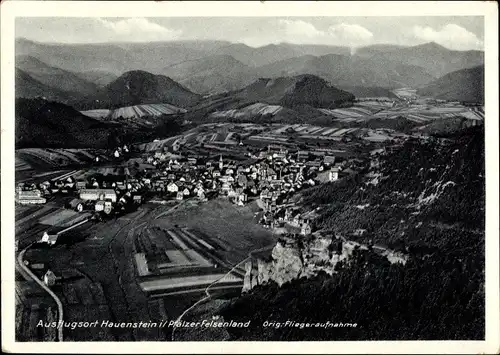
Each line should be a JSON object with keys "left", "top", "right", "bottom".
{"left": 16, "top": 144, "right": 350, "bottom": 243}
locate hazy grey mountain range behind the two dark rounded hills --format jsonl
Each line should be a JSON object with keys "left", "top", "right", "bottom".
{"left": 16, "top": 39, "right": 484, "bottom": 97}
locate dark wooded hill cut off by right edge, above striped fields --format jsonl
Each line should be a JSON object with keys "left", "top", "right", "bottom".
{"left": 418, "top": 65, "right": 484, "bottom": 103}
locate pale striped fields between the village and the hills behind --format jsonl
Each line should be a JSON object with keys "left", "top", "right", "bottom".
{"left": 138, "top": 101, "right": 484, "bottom": 153}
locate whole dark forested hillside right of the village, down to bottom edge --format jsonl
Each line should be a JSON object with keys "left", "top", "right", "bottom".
{"left": 218, "top": 127, "right": 485, "bottom": 340}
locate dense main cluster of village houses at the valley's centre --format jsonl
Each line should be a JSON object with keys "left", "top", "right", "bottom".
{"left": 139, "top": 145, "right": 343, "bottom": 210}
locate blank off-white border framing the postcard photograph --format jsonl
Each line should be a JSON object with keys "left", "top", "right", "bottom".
{"left": 0, "top": 0, "right": 500, "bottom": 354}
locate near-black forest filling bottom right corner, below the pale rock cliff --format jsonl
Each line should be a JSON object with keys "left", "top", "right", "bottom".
{"left": 219, "top": 245, "right": 485, "bottom": 341}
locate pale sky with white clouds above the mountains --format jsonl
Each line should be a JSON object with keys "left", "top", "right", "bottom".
{"left": 16, "top": 16, "right": 484, "bottom": 50}
